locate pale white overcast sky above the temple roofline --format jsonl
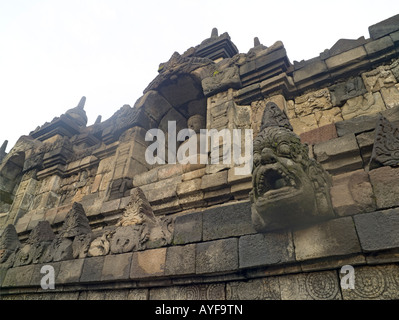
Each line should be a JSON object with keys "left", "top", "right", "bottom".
{"left": 0, "top": 0, "right": 399, "bottom": 151}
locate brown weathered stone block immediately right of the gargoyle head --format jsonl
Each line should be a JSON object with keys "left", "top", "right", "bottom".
{"left": 330, "top": 170, "right": 376, "bottom": 216}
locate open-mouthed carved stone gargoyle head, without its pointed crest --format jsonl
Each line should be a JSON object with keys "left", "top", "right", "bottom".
{"left": 250, "top": 127, "right": 333, "bottom": 231}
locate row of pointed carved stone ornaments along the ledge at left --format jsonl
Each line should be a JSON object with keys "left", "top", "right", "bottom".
{"left": 0, "top": 188, "right": 173, "bottom": 268}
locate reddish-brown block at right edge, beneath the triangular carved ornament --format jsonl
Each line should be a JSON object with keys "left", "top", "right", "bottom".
{"left": 369, "top": 167, "right": 399, "bottom": 209}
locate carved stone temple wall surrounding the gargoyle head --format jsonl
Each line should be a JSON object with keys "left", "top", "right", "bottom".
{"left": 0, "top": 15, "right": 399, "bottom": 300}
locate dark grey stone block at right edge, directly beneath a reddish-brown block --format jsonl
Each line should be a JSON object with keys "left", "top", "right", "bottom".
{"left": 354, "top": 209, "right": 399, "bottom": 252}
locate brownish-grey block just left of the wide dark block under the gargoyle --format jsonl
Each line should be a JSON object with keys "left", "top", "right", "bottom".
{"left": 195, "top": 238, "right": 238, "bottom": 274}
